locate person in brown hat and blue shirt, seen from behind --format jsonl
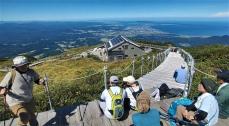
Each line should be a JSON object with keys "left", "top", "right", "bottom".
{"left": 132, "top": 91, "right": 160, "bottom": 126}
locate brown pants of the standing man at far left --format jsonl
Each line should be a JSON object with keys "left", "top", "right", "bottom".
{"left": 10, "top": 101, "right": 38, "bottom": 126}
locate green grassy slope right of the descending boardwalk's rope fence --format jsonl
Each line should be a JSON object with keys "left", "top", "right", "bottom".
{"left": 185, "top": 45, "right": 229, "bottom": 97}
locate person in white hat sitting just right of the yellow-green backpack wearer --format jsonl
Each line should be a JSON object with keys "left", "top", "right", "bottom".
{"left": 123, "top": 76, "right": 143, "bottom": 110}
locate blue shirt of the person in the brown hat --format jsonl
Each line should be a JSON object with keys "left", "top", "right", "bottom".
{"left": 132, "top": 108, "right": 160, "bottom": 126}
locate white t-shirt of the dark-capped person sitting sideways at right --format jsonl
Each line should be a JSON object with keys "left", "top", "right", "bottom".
{"left": 195, "top": 93, "right": 219, "bottom": 126}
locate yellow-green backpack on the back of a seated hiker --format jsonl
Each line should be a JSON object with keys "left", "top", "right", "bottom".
{"left": 108, "top": 89, "right": 124, "bottom": 119}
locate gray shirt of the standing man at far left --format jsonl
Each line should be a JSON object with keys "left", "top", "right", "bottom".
{"left": 0, "top": 69, "right": 39, "bottom": 107}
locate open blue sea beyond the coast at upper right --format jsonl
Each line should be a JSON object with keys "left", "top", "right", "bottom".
{"left": 149, "top": 21, "right": 229, "bottom": 36}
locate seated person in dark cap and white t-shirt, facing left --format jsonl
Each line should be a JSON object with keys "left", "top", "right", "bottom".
{"left": 175, "top": 78, "right": 219, "bottom": 126}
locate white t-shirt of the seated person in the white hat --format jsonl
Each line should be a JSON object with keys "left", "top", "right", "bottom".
{"left": 125, "top": 86, "right": 143, "bottom": 107}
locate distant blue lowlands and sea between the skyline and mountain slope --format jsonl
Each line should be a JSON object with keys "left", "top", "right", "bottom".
{"left": 0, "top": 21, "right": 229, "bottom": 58}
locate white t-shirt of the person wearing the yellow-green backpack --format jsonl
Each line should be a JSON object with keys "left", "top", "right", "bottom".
{"left": 101, "top": 86, "right": 126, "bottom": 118}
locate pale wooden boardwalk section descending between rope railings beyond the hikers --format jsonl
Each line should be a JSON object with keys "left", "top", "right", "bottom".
{"left": 138, "top": 52, "right": 187, "bottom": 90}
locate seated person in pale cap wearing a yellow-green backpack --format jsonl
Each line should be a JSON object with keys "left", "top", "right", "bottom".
{"left": 99, "top": 76, "right": 126, "bottom": 119}
